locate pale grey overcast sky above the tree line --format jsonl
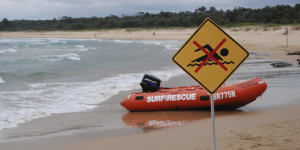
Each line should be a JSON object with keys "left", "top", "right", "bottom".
{"left": 0, "top": 0, "right": 300, "bottom": 20}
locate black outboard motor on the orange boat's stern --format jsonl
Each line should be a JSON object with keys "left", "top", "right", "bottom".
{"left": 140, "top": 74, "right": 161, "bottom": 92}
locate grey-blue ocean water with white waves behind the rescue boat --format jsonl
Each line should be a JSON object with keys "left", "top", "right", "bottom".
{"left": 0, "top": 39, "right": 300, "bottom": 132}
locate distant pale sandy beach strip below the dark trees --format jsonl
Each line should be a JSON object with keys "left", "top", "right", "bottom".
{"left": 0, "top": 26, "right": 300, "bottom": 64}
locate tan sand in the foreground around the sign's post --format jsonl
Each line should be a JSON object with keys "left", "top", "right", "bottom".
{"left": 63, "top": 103, "right": 300, "bottom": 150}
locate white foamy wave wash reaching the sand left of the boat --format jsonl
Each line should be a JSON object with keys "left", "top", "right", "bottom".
{"left": 0, "top": 69, "right": 183, "bottom": 129}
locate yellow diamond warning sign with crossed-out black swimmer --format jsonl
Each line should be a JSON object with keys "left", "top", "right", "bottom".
{"left": 173, "top": 19, "right": 249, "bottom": 93}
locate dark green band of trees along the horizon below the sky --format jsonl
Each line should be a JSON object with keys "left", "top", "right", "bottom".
{"left": 0, "top": 4, "right": 300, "bottom": 31}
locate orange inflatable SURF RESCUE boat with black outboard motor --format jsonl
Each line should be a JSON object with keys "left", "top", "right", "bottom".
{"left": 120, "top": 75, "right": 267, "bottom": 111}
